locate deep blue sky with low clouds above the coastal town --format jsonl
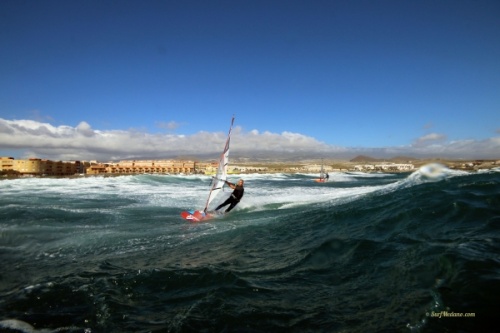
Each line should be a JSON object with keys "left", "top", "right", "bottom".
{"left": 0, "top": 0, "right": 500, "bottom": 161}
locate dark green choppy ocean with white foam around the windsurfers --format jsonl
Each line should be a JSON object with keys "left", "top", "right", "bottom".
{"left": 0, "top": 165, "right": 500, "bottom": 333}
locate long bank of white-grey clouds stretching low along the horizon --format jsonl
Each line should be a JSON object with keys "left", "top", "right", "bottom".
{"left": 0, "top": 118, "right": 500, "bottom": 161}
